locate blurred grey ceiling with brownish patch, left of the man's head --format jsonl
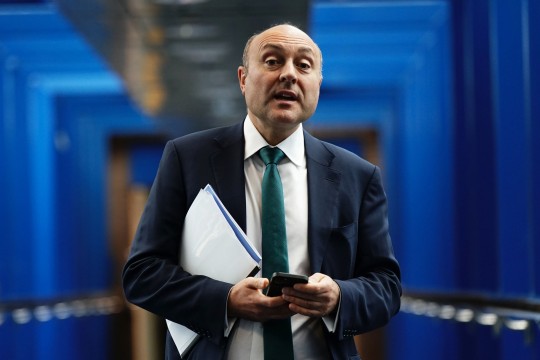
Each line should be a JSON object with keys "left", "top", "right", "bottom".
{"left": 58, "top": 0, "right": 309, "bottom": 129}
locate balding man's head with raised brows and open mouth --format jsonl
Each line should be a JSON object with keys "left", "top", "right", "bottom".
{"left": 238, "top": 25, "right": 322, "bottom": 141}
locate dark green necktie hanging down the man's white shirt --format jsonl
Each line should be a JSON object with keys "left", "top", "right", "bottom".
{"left": 259, "top": 146, "right": 294, "bottom": 360}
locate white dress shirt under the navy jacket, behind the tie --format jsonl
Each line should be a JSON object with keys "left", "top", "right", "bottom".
{"left": 227, "top": 116, "right": 335, "bottom": 360}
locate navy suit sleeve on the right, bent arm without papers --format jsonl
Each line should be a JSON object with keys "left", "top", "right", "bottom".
{"left": 330, "top": 167, "right": 401, "bottom": 340}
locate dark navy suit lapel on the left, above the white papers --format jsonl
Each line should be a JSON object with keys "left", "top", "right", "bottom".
{"left": 211, "top": 122, "right": 246, "bottom": 231}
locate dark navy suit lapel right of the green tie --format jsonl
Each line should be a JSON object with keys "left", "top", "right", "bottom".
{"left": 304, "top": 132, "right": 341, "bottom": 273}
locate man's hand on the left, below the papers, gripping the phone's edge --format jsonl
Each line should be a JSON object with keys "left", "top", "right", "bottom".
{"left": 227, "top": 277, "right": 295, "bottom": 322}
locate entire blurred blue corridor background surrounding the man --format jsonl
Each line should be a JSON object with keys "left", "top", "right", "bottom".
{"left": 0, "top": 0, "right": 540, "bottom": 360}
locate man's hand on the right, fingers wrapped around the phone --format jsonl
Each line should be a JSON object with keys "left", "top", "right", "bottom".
{"left": 283, "top": 273, "right": 340, "bottom": 317}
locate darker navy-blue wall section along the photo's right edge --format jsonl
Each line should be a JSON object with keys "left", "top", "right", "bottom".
{"left": 454, "top": 0, "right": 540, "bottom": 359}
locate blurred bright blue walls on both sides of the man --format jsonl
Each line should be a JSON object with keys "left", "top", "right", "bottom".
{"left": 0, "top": 0, "right": 540, "bottom": 359}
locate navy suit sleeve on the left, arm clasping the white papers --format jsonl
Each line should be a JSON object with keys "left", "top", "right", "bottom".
{"left": 123, "top": 142, "right": 232, "bottom": 344}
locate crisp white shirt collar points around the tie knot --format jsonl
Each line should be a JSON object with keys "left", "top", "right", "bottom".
{"left": 244, "top": 116, "right": 306, "bottom": 166}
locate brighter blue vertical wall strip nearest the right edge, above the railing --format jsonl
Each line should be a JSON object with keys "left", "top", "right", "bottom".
{"left": 491, "top": 1, "right": 533, "bottom": 296}
